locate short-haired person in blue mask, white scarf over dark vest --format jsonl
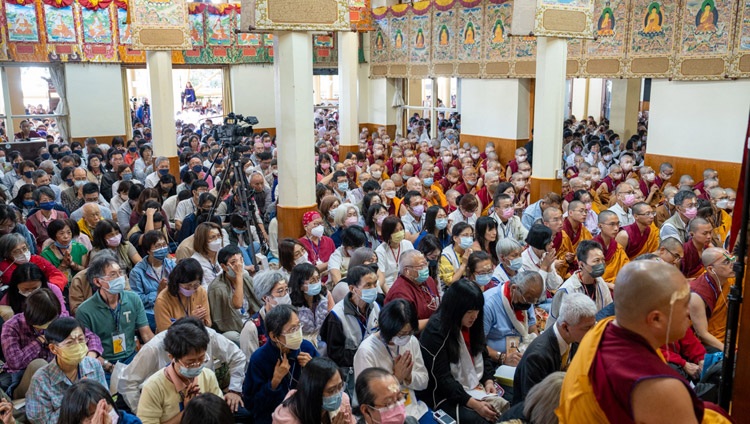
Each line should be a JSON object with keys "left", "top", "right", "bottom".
{"left": 320, "top": 265, "right": 380, "bottom": 394}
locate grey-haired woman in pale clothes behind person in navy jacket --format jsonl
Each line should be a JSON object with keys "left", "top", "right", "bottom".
{"left": 240, "top": 271, "right": 292, "bottom": 358}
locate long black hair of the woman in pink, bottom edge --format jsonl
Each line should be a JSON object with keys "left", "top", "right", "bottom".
{"left": 282, "top": 357, "right": 344, "bottom": 424}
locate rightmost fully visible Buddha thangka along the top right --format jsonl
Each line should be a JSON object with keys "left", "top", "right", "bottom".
{"left": 674, "top": 0, "right": 737, "bottom": 80}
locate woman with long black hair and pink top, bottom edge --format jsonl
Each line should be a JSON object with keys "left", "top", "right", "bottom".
{"left": 273, "top": 358, "right": 357, "bottom": 424}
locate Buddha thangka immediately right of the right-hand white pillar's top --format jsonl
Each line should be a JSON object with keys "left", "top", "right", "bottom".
{"left": 582, "top": 0, "right": 628, "bottom": 77}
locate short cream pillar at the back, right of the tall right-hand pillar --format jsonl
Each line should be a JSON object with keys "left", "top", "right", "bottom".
{"left": 609, "top": 78, "right": 641, "bottom": 140}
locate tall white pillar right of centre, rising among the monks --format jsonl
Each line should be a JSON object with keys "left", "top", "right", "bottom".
{"left": 532, "top": 37, "right": 568, "bottom": 181}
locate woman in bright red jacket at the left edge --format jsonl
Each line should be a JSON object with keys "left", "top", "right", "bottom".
{"left": 0, "top": 233, "right": 68, "bottom": 290}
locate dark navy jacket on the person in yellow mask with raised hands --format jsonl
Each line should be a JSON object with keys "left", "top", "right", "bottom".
{"left": 242, "top": 340, "right": 319, "bottom": 424}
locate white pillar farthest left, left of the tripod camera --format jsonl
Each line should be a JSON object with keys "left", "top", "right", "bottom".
{"left": 146, "top": 51, "right": 177, "bottom": 157}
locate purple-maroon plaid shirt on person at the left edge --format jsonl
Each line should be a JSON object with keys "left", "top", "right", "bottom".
{"left": 0, "top": 313, "right": 102, "bottom": 373}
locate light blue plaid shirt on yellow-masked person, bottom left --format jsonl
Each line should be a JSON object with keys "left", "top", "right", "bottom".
{"left": 26, "top": 357, "right": 109, "bottom": 424}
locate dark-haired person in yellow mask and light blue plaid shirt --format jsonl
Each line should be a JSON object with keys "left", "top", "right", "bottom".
{"left": 26, "top": 317, "right": 109, "bottom": 424}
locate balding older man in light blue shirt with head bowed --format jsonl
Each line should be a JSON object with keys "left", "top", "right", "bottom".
{"left": 484, "top": 271, "right": 544, "bottom": 367}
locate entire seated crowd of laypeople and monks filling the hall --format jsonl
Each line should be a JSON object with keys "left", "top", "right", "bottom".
{"left": 0, "top": 109, "right": 736, "bottom": 424}
